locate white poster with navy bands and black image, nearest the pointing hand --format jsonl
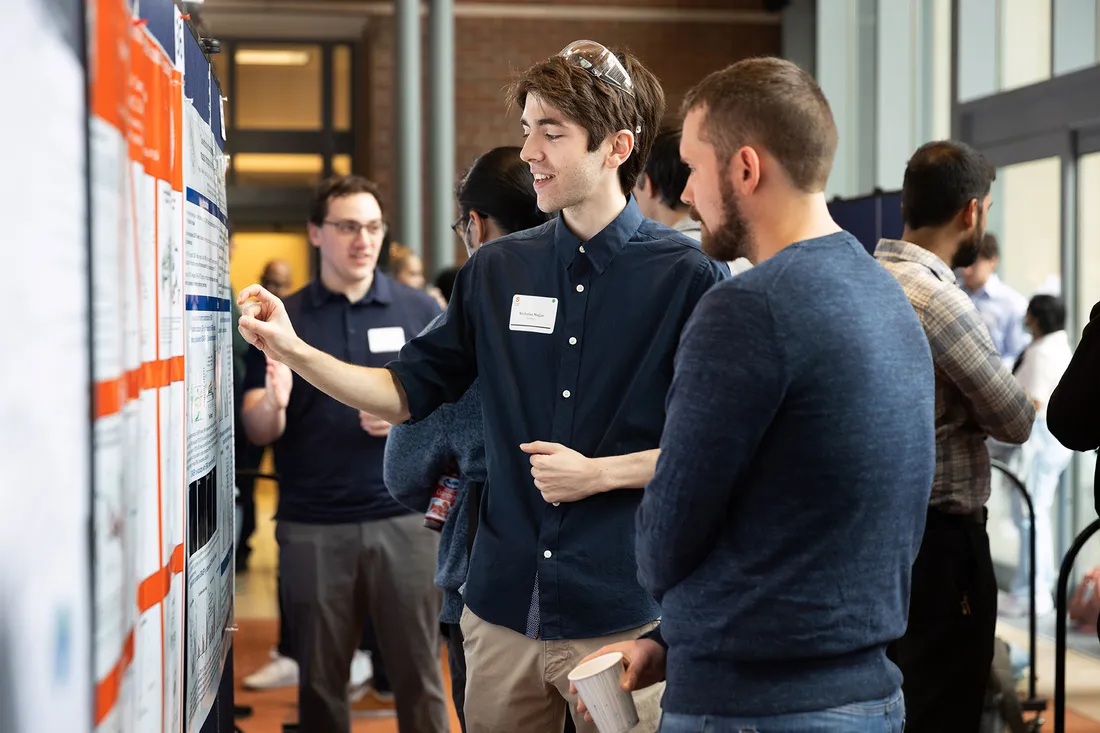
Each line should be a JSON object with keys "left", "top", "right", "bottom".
{"left": 184, "top": 93, "right": 234, "bottom": 732}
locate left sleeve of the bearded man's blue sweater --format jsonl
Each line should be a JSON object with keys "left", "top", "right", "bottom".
{"left": 637, "top": 280, "right": 787, "bottom": 603}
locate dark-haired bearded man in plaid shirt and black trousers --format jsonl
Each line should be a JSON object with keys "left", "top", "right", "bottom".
{"left": 875, "top": 141, "right": 1035, "bottom": 733}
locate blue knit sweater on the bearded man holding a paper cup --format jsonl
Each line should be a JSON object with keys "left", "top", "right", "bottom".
{"left": 637, "top": 233, "right": 936, "bottom": 716}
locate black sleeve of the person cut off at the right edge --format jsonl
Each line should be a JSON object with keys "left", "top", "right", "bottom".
{"left": 1046, "top": 303, "right": 1100, "bottom": 450}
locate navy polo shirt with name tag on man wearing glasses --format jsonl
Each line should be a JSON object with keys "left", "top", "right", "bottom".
{"left": 244, "top": 272, "right": 439, "bottom": 524}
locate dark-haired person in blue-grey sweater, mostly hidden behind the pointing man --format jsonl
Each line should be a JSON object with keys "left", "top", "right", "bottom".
{"left": 383, "top": 147, "right": 554, "bottom": 731}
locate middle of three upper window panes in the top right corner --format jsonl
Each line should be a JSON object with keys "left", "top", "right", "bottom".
{"left": 1000, "top": 0, "right": 1051, "bottom": 90}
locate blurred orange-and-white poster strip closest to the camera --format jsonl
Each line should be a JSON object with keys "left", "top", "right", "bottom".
{"left": 88, "top": 0, "right": 139, "bottom": 732}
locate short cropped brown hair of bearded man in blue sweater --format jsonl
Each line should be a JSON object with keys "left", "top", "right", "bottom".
{"left": 682, "top": 57, "right": 837, "bottom": 193}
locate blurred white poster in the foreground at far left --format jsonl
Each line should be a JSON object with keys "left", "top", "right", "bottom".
{"left": 0, "top": 0, "right": 92, "bottom": 733}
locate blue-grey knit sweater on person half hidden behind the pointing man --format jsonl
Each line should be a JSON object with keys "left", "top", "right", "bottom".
{"left": 383, "top": 376, "right": 485, "bottom": 624}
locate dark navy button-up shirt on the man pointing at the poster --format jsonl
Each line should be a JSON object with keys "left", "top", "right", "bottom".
{"left": 388, "top": 197, "right": 729, "bottom": 639}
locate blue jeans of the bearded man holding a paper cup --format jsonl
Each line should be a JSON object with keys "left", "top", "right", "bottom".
{"left": 660, "top": 690, "right": 905, "bottom": 733}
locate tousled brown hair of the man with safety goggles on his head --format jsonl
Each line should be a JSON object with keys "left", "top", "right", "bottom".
{"left": 507, "top": 45, "right": 664, "bottom": 195}
